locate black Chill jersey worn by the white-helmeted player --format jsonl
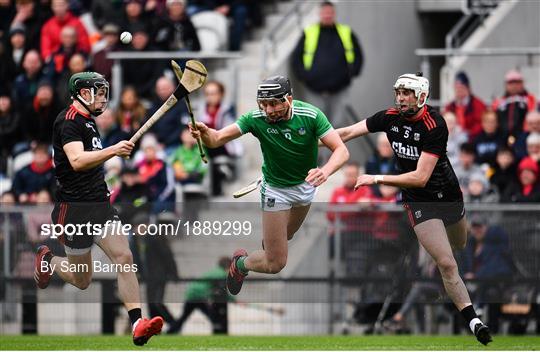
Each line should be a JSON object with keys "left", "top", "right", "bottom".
{"left": 366, "top": 105, "right": 460, "bottom": 201}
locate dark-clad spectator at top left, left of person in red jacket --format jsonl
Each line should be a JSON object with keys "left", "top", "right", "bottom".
{"left": 10, "top": 0, "right": 50, "bottom": 50}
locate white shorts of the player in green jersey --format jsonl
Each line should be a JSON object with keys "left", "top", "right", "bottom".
{"left": 261, "top": 179, "right": 317, "bottom": 211}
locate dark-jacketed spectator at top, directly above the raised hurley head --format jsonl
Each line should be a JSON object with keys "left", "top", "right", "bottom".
{"left": 155, "top": 0, "right": 201, "bottom": 51}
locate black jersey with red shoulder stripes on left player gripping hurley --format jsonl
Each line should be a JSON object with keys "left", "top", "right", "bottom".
{"left": 53, "top": 105, "right": 109, "bottom": 202}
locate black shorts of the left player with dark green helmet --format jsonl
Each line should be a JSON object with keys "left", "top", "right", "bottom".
{"left": 51, "top": 202, "right": 120, "bottom": 254}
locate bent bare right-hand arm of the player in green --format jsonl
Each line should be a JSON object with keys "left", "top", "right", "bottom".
{"left": 306, "top": 130, "right": 349, "bottom": 186}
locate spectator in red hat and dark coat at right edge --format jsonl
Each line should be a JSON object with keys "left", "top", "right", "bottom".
{"left": 501, "top": 157, "right": 540, "bottom": 203}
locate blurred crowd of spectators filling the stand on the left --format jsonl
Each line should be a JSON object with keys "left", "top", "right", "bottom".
{"left": 0, "top": 0, "right": 262, "bottom": 206}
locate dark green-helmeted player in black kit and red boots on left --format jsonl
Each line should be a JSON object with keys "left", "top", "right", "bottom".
{"left": 34, "top": 72, "right": 163, "bottom": 345}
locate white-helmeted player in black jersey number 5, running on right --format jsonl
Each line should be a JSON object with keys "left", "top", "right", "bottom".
{"left": 337, "top": 74, "right": 491, "bottom": 345}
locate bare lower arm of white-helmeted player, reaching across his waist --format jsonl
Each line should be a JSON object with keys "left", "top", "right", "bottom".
{"left": 355, "top": 152, "right": 439, "bottom": 188}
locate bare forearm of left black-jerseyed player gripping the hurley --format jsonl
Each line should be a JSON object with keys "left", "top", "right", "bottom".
{"left": 63, "top": 141, "right": 135, "bottom": 171}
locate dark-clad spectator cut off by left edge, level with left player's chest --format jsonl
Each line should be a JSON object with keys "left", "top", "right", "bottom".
{"left": 0, "top": 93, "right": 22, "bottom": 179}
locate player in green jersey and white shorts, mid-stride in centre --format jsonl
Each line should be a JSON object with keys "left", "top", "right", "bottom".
{"left": 190, "top": 76, "right": 349, "bottom": 295}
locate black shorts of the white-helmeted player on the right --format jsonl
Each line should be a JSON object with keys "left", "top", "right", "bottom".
{"left": 403, "top": 191, "right": 465, "bottom": 227}
